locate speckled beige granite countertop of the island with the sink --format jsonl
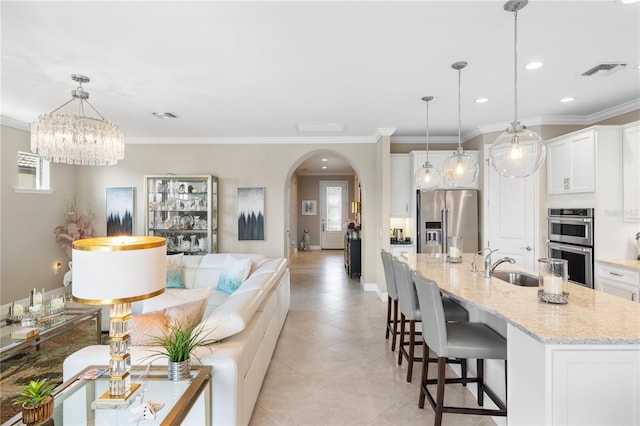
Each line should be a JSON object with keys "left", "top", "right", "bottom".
{"left": 403, "top": 253, "right": 640, "bottom": 345}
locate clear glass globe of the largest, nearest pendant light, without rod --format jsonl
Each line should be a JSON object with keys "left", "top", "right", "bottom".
{"left": 489, "top": 126, "right": 546, "bottom": 178}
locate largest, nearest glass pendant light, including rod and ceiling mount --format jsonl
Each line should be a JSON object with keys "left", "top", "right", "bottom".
{"left": 489, "top": 0, "right": 545, "bottom": 178}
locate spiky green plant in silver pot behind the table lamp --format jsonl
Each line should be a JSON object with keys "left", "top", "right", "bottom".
{"left": 147, "top": 319, "right": 218, "bottom": 380}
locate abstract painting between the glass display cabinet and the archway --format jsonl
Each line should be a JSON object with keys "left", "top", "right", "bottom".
{"left": 238, "top": 187, "right": 264, "bottom": 241}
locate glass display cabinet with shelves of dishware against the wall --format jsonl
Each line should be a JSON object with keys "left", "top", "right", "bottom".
{"left": 145, "top": 175, "right": 218, "bottom": 254}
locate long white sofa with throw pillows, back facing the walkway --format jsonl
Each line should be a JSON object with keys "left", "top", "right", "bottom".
{"left": 62, "top": 254, "right": 290, "bottom": 425}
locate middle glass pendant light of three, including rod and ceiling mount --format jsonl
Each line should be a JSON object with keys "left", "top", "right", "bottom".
{"left": 443, "top": 61, "right": 478, "bottom": 187}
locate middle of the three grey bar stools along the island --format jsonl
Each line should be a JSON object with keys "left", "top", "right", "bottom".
{"left": 392, "top": 257, "right": 469, "bottom": 382}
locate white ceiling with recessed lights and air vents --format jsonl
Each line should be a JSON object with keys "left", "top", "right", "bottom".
{"left": 0, "top": 0, "right": 640, "bottom": 155}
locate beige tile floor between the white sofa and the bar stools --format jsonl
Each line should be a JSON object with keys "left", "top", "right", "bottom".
{"left": 250, "top": 250, "right": 495, "bottom": 426}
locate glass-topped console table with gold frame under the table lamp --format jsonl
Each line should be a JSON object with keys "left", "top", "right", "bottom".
{"left": 5, "top": 365, "right": 211, "bottom": 425}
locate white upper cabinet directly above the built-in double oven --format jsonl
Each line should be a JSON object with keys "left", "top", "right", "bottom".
{"left": 547, "top": 128, "right": 596, "bottom": 194}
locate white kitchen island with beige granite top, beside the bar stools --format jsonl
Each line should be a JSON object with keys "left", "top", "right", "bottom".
{"left": 403, "top": 254, "right": 640, "bottom": 425}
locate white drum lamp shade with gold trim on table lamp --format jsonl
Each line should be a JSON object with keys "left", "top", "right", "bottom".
{"left": 72, "top": 237, "right": 167, "bottom": 305}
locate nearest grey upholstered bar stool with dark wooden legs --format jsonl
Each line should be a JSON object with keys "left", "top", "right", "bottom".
{"left": 413, "top": 272, "right": 507, "bottom": 426}
